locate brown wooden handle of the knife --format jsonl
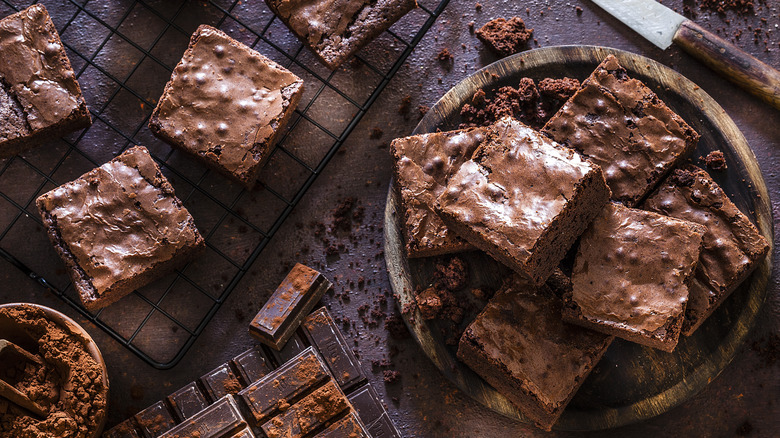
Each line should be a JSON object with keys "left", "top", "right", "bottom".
{"left": 673, "top": 20, "right": 780, "bottom": 109}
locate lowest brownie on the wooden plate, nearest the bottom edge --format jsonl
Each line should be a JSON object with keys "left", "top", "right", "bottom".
{"left": 458, "top": 276, "right": 613, "bottom": 431}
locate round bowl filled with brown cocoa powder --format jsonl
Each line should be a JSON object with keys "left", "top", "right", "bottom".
{"left": 0, "top": 303, "right": 108, "bottom": 438}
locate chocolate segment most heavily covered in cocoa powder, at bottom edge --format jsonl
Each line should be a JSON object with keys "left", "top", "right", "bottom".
{"left": 262, "top": 380, "right": 350, "bottom": 438}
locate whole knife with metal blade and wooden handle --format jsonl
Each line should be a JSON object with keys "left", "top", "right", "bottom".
{"left": 592, "top": 0, "right": 780, "bottom": 109}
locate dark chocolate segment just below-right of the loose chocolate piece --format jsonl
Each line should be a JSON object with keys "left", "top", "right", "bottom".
{"left": 303, "top": 307, "right": 365, "bottom": 391}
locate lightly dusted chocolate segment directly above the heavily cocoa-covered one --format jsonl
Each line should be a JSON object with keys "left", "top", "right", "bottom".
{"left": 238, "top": 347, "right": 330, "bottom": 423}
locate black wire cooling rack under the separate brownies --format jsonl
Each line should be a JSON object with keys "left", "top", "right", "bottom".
{"left": 0, "top": 0, "right": 449, "bottom": 369}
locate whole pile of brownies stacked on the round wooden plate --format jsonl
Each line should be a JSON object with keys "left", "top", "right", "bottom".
{"left": 392, "top": 55, "right": 769, "bottom": 430}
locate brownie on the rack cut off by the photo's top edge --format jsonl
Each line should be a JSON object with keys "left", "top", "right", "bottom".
{"left": 265, "top": 0, "right": 417, "bottom": 70}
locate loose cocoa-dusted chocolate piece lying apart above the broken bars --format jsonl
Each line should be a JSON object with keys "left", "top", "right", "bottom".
{"left": 249, "top": 263, "right": 333, "bottom": 351}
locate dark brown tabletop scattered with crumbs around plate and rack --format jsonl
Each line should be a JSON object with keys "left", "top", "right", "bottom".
{"left": 0, "top": 0, "right": 780, "bottom": 437}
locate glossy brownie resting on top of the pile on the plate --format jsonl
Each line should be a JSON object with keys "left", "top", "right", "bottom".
{"left": 435, "top": 117, "right": 610, "bottom": 285}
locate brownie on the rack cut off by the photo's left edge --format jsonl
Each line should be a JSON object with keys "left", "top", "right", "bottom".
{"left": 0, "top": 5, "right": 92, "bottom": 158}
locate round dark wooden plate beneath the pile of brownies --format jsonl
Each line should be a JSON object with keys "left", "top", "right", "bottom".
{"left": 385, "top": 46, "right": 773, "bottom": 430}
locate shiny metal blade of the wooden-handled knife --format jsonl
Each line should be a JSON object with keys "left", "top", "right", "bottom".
{"left": 592, "top": 0, "right": 686, "bottom": 50}
